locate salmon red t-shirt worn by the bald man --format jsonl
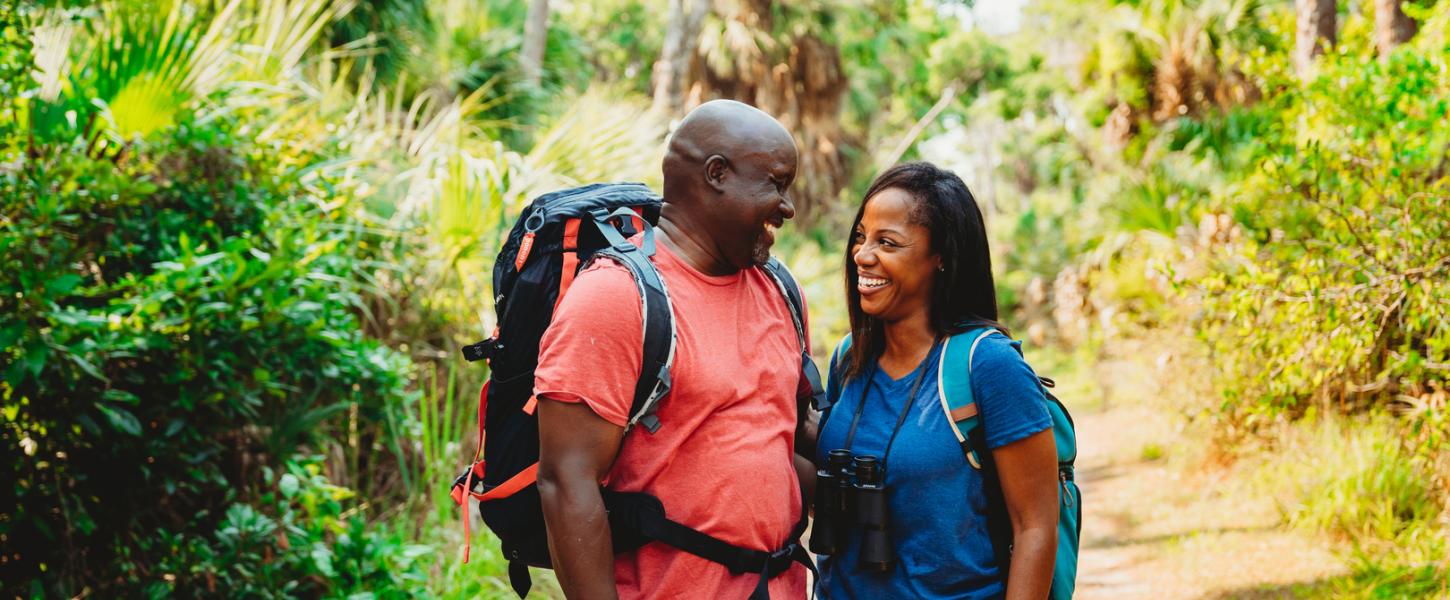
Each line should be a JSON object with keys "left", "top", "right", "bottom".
{"left": 534, "top": 245, "right": 805, "bottom": 599}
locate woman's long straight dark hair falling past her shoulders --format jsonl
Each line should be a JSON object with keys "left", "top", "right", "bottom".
{"left": 841, "top": 162, "right": 1006, "bottom": 380}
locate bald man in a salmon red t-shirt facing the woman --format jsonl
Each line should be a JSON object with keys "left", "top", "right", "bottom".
{"left": 534, "top": 100, "right": 805, "bottom": 599}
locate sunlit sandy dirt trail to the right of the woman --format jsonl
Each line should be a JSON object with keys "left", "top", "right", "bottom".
{"left": 1064, "top": 342, "right": 1346, "bottom": 600}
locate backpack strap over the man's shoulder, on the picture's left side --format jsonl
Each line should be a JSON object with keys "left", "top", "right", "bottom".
{"left": 590, "top": 209, "right": 676, "bottom": 433}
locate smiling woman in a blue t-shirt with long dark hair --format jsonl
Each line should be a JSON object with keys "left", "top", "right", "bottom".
{"left": 812, "top": 162, "right": 1057, "bottom": 599}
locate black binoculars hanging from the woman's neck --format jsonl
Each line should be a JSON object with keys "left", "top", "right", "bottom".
{"left": 811, "top": 449, "right": 896, "bottom": 572}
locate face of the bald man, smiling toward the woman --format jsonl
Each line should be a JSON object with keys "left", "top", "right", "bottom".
{"left": 718, "top": 143, "right": 796, "bottom": 268}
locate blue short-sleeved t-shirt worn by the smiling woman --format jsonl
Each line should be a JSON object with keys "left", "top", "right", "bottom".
{"left": 816, "top": 335, "right": 1053, "bottom": 599}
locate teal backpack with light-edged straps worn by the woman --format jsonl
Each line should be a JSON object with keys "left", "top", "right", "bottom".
{"left": 832, "top": 329, "right": 1083, "bottom": 600}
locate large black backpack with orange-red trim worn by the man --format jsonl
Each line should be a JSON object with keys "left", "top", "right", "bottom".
{"left": 451, "top": 184, "right": 824, "bottom": 597}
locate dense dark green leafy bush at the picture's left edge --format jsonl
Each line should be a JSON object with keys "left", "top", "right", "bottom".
{"left": 0, "top": 122, "right": 409, "bottom": 594}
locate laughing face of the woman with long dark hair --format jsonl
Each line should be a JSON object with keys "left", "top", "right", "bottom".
{"left": 851, "top": 188, "right": 941, "bottom": 323}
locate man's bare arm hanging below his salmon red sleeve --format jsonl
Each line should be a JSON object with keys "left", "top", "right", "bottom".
{"left": 538, "top": 397, "right": 624, "bottom": 599}
